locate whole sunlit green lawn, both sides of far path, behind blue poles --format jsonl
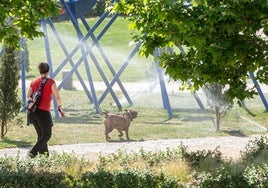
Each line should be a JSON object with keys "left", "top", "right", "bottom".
{"left": 0, "top": 18, "right": 268, "bottom": 148}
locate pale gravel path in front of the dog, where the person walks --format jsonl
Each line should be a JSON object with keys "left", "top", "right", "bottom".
{"left": 0, "top": 135, "right": 264, "bottom": 160}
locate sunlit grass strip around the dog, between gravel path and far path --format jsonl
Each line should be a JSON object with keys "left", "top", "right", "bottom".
{"left": 0, "top": 90, "right": 268, "bottom": 148}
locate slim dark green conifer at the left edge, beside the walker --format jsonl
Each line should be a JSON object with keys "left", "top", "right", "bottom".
{"left": 0, "top": 47, "right": 20, "bottom": 138}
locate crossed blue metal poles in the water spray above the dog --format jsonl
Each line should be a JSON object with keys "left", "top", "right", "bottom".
{"left": 41, "top": 0, "right": 172, "bottom": 117}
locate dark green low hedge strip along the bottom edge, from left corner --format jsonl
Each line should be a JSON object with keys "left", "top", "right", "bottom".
{"left": 0, "top": 169, "right": 179, "bottom": 188}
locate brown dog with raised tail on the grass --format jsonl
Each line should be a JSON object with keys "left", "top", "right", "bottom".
{"left": 98, "top": 106, "right": 138, "bottom": 141}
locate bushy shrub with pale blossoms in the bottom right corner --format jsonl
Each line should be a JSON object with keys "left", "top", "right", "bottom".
{"left": 189, "top": 136, "right": 268, "bottom": 188}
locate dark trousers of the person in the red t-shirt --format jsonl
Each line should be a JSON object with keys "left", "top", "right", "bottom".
{"left": 29, "top": 109, "right": 53, "bottom": 157}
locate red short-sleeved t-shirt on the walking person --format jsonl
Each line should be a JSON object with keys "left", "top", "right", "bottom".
{"left": 30, "top": 77, "right": 55, "bottom": 111}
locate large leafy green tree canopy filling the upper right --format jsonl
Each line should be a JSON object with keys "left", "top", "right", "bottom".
{"left": 114, "top": 0, "right": 268, "bottom": 102}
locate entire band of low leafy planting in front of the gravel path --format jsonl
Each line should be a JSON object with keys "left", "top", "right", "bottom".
{"left": 0, "top": 136, "right": 268, "bottom": 188}
